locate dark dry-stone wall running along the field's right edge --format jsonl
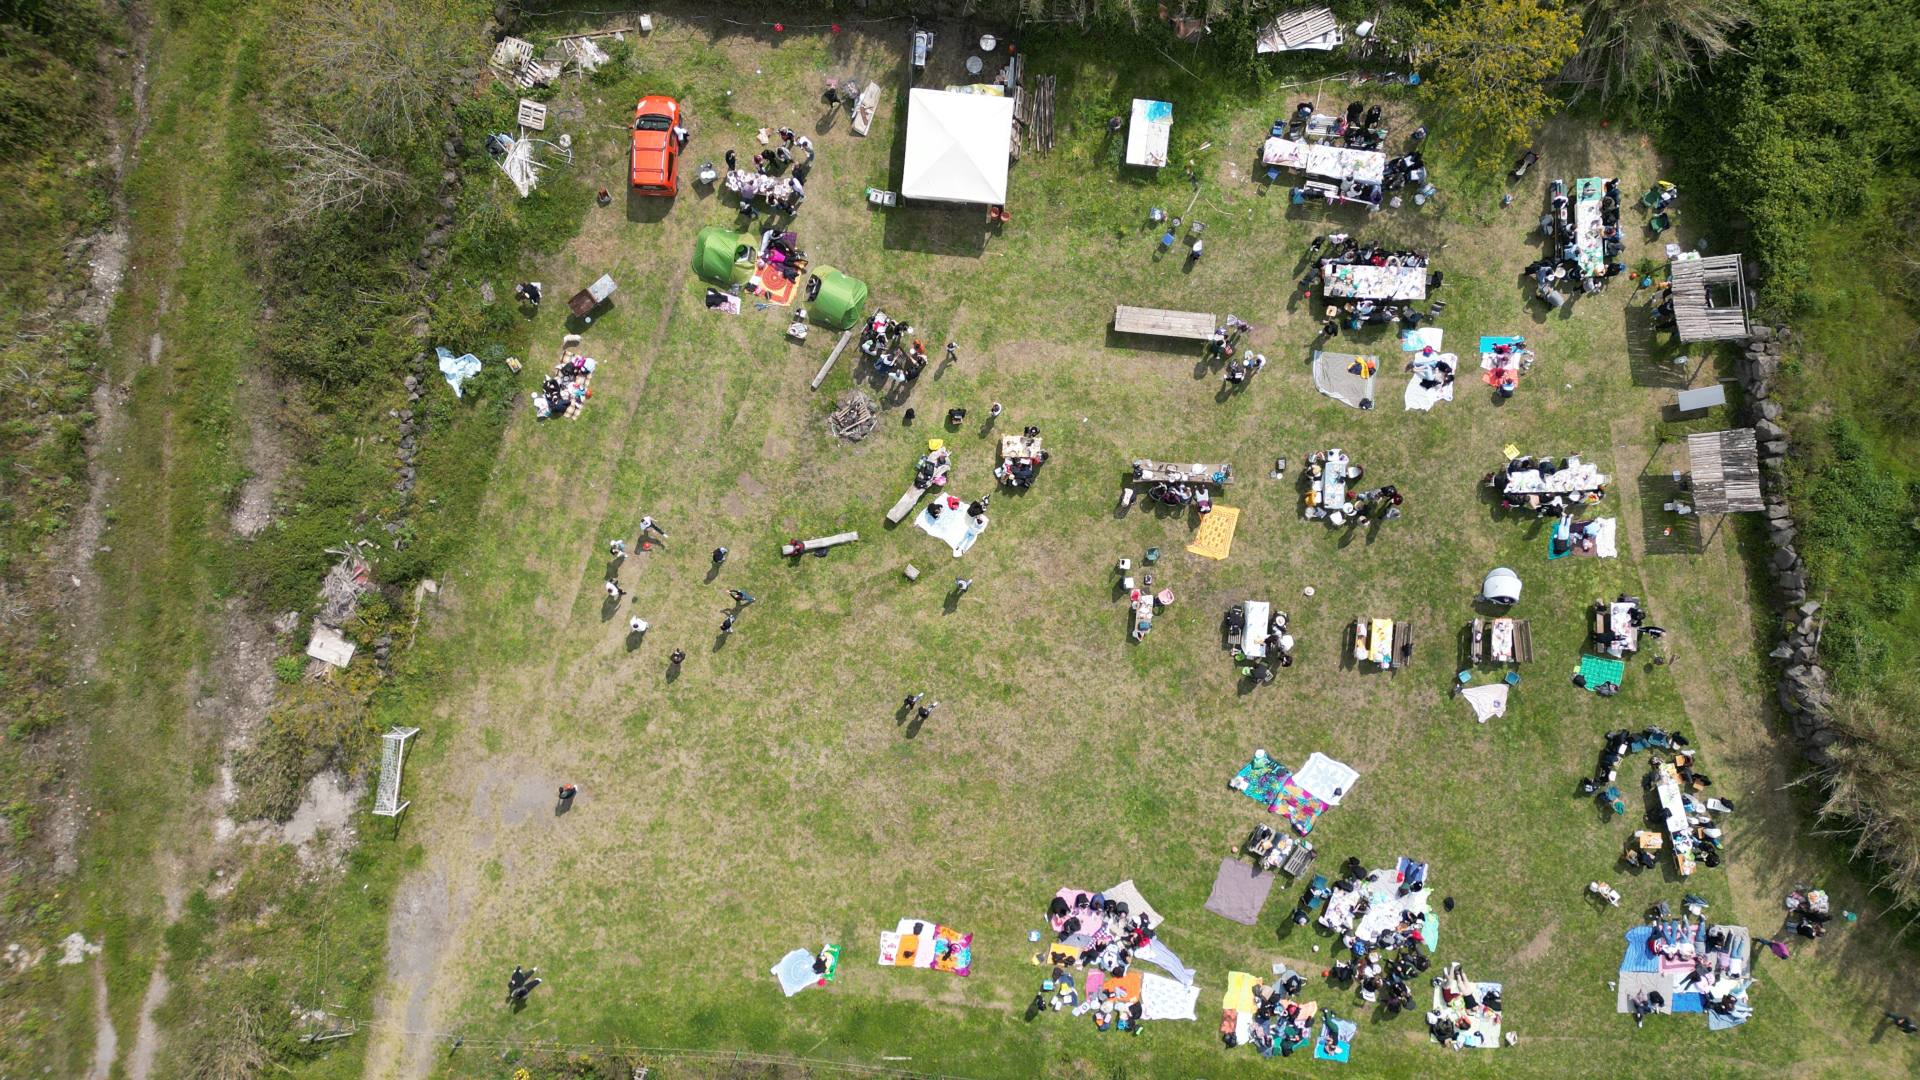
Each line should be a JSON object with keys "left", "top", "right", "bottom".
{"left": 1740, "top": 327, "right": 1839, "bottom": 765}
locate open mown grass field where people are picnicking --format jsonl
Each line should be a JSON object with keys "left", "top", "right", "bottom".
{"left": 369, "top": 23, "right": 1920, "bottom": 1076}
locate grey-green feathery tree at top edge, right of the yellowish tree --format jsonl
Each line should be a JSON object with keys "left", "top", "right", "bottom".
{"left": 1567, "top": 0, "right": 1753, "bottom": 102}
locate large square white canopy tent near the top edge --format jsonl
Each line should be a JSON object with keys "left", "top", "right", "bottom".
{"left": 900, "top": 88, "right": 1014, "bottom": 206}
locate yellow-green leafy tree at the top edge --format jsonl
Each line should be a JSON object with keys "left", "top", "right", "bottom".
{"left": 1425, "top": 0, "right": 1580, "bottom": 160}
